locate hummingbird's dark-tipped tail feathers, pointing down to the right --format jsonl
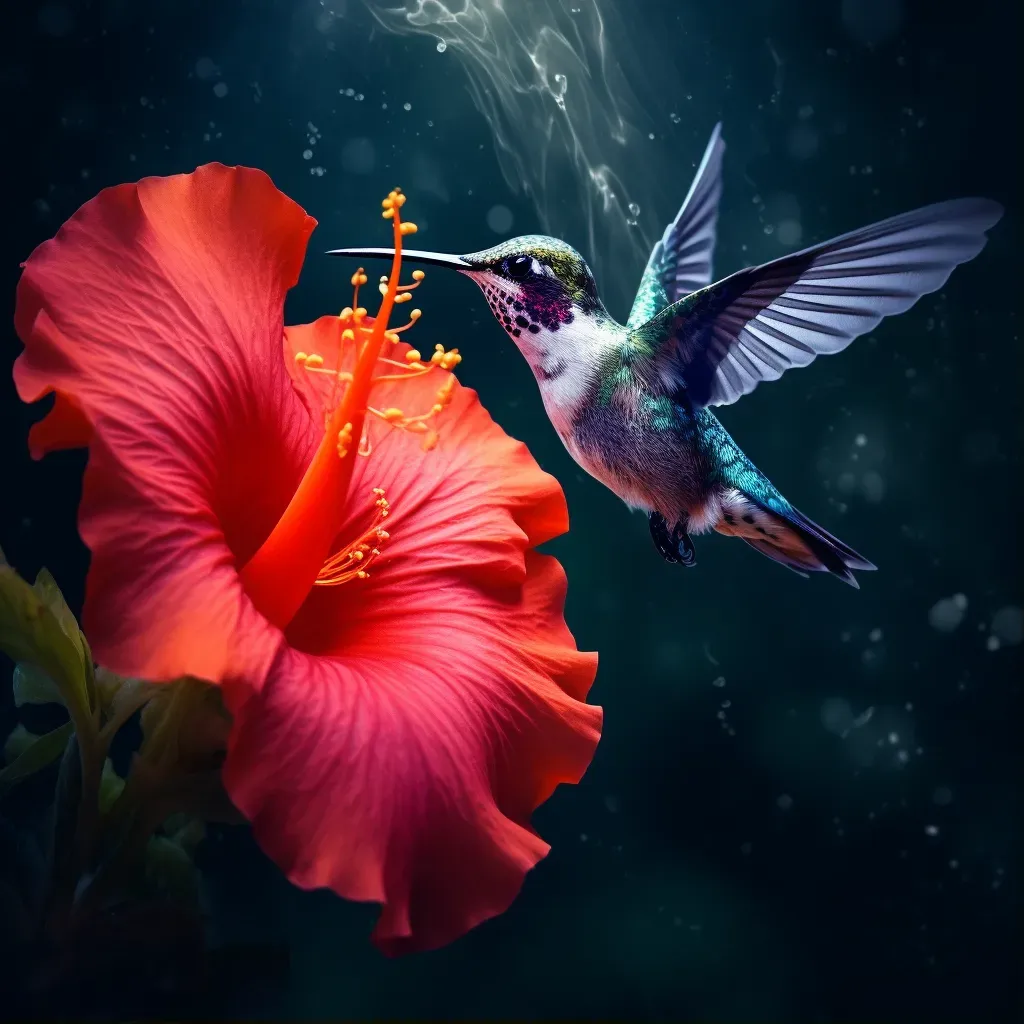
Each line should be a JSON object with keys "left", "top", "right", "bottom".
{"left": 715, "top": 490, "right": 877, "bottom": 588}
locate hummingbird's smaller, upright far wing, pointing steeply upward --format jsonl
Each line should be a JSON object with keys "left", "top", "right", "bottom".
{"left": 626, "top": 124, "right": 725, "bottom": 327}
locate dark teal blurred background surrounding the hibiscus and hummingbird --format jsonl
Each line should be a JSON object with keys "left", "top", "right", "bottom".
{"left": 0, "top": 0, "right": 1024, "bottom": 1022}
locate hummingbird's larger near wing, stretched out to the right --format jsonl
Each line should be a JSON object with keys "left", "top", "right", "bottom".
{"left": 635, "top": 199, "right": 1002, "bottom": 406}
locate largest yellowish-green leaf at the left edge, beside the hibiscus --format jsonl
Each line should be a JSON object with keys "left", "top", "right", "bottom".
{"left": 0, "top": 562, "right": 90, "bottom": 722}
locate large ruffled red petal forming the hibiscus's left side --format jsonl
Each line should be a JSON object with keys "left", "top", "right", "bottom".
{"left": 14, "top": 164, "right": 315, "bottom": 685}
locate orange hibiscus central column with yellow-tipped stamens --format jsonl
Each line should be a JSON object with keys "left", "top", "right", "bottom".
{"left": 241, "top": 189, "right": 462, "bottom": 629}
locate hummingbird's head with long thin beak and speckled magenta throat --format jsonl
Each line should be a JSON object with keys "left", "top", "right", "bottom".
{"left": 330, "top": 234, "right": 622, "bottom": 413}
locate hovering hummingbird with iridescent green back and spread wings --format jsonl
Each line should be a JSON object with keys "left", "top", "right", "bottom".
{"left": 332, "top": 125, "right": 1002, "bottom": 587}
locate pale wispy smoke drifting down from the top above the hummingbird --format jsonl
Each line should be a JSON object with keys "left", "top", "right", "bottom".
{"left": 365, "top": 0, "right": 682, "bottom": 313}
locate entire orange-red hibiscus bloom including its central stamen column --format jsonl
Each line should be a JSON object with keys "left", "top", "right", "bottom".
{"left": 14, "top": 159, "right": 601, "bottom": 952}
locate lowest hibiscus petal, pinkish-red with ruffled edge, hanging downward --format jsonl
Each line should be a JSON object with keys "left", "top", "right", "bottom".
{"left": 224, "top": 553, "right": 601, "bottom": 954}
